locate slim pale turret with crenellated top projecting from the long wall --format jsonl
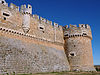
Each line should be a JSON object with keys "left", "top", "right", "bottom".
{"left": 21, "top": 5, "right": 32, "bottom": 33}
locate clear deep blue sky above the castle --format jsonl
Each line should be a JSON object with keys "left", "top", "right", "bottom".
{"left": 6, "top": 0, "right": 100, "bottom": 65}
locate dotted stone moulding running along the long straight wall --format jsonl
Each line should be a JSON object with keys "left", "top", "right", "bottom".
{"left": 0, "top": 27, "right": 64, "bottom": 46}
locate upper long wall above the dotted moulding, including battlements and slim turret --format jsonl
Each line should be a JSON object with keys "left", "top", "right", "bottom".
{"left": 0, "top": 0, "right": 64, "bottom": 44}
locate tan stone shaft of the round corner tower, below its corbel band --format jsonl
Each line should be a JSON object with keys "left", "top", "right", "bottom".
{"left": 65, "top": 36, "right": 95, "bottom": 71}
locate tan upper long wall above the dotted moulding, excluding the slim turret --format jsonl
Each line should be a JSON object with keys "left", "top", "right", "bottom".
{"left": 0, "top": 4, "right": 64, "bottom": 43}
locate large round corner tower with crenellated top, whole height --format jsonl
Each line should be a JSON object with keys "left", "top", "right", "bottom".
{"left": 64, "top": 24, "right": 96, "bottom": 71}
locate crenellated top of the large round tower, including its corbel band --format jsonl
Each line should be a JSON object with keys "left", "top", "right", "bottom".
{"left": 64, "top": 24, "right": 92, "bottom": 39}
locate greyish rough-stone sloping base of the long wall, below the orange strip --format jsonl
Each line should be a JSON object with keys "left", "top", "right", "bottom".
{"left": 0, "top": 36, "right": 70, "bottom": 73}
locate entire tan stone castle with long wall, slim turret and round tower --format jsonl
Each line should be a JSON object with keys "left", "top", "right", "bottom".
{"left": 0, "top": 0, "right": 96, "bottom": 74}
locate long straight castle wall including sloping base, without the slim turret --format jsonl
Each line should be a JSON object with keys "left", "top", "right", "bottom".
{"left": 0, "top": 1, "right": 70, "bottom": 74}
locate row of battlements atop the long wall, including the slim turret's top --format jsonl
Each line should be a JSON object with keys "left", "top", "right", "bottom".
{"left": 0, "top": 0, "right": 61, "bottom": 30}
